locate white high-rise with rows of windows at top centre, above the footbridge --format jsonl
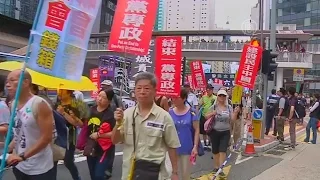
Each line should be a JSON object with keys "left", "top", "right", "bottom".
{"left": 163, "top": 0, "right": 215, "bottom": 31}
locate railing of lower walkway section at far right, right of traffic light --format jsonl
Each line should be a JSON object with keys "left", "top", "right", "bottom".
{"left": 276, "top": 52, "right": 312, "bottom": 63}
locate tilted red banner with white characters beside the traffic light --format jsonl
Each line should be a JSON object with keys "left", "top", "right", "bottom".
{"left": 235, "top": 44, "right": 262, "bottom": 89}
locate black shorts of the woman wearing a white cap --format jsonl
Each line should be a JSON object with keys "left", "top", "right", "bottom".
{"left": 209, "top": 130, "right": 231, "bottom": 154}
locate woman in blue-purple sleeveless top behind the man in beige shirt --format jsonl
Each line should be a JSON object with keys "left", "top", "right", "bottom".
{"left": 169, "top": 89, "right": 200, "bottom": 180}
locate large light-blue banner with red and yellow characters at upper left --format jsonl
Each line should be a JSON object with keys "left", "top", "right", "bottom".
{"left": 28, "top": 0, "right": 101, "bottom": 81}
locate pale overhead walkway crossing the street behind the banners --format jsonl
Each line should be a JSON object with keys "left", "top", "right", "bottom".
{"left": 87, "top": 42, "right": 320, "bottom": 69}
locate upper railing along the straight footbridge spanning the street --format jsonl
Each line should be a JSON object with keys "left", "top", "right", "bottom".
{"left": 88, "top": 42, "right": 320, "bottom": 53}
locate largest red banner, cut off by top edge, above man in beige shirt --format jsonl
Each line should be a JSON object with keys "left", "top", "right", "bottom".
{"left": 108, "top": 0, "right": 158, "bottom": 55}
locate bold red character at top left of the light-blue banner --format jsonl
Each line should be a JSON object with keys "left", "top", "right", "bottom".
{"left": 46, "top": 1, "right": 70, "bottom": 31}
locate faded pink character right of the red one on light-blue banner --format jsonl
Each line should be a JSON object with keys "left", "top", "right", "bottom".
{"left": 70, "top": 11, "right": 91, "bottom": 39}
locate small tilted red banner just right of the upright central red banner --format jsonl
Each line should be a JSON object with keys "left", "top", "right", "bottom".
{"left": 190, "top": 61, "right": 207, "bottom": 89}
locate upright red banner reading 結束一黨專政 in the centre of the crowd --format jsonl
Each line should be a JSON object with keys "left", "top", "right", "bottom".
{"left": 155, "top": 37, "right": 182, "bottom": 97}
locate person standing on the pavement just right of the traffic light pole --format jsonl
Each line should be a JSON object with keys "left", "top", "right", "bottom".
{"left": 265, "top": 89, "right": 280, "bottom": 136}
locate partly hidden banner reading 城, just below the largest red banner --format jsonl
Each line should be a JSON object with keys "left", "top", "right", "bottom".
{"left": 131, "top": 40, "right": 155, "bottom": 77}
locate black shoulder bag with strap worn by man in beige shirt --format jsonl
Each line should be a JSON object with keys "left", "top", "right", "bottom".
{"left": 128, "top": 107, "right": 161, "bottom": 180}
